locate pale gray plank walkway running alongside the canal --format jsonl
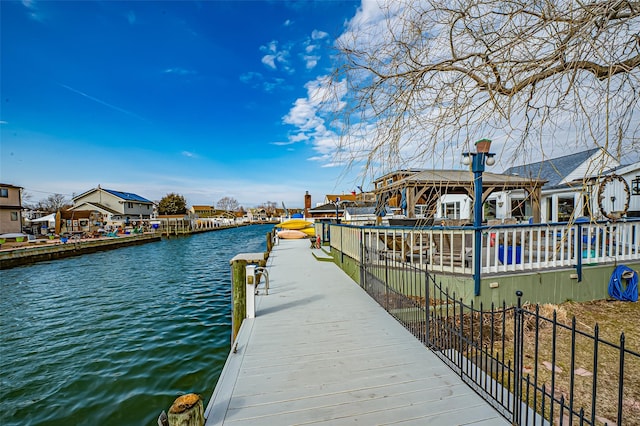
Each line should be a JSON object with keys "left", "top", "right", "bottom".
{"left": 205, "top": 240, "right": 509, "bottom": 426}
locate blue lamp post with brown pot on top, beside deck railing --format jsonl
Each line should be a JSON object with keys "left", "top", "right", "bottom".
{"left": 462, "top": 139, "right": 496, "bottom": 296}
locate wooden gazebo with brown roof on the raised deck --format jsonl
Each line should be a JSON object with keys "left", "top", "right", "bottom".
{"left": 374, "top": 170, "right": 546, "bottom": 223}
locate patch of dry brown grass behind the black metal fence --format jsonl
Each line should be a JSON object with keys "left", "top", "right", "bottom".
{"left": 497, "top": 300, "right": 640, "bottom": 425}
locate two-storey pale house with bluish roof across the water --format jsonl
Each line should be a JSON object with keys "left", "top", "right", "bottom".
{"left": 69, "top": 186, "right": 154, "bottom": 223}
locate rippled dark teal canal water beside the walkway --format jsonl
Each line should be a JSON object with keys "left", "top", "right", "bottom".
{"left": 0, "top": 225, "right": 272, "bottom": 426}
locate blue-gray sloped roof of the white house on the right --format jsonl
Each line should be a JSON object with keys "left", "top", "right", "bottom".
{"left": 504, "top": 148, "right": 600, "bottom": 187}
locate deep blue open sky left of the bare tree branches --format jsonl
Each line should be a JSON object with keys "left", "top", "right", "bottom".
{"left": 0, "top": 0, "right": 366, "bottom": 207}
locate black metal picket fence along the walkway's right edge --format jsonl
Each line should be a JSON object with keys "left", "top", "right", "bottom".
{"left": 361, "top": 249, "right": 640, "bottom": 425}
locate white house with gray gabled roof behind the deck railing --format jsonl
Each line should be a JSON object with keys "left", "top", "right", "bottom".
{"left": 500, "top": 148, "right": 640, "bottom": 222}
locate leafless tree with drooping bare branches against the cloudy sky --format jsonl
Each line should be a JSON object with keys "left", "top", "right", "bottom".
{"left": 330, "top": 0, "right": 640, "bottom": 176}
